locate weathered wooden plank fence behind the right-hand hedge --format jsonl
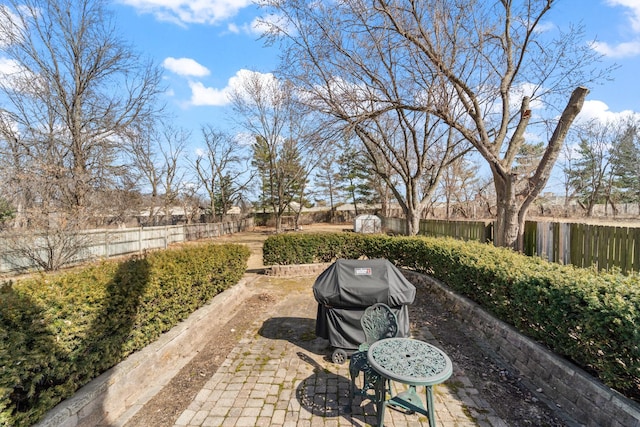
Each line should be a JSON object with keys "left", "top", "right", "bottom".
{"left": 383, "top": 218, "right": 640, "bottom": 273}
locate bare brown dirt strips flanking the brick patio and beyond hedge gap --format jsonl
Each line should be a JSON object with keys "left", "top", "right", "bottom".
{"left": 126, "top": 225, "right": 567, "bottom": 427}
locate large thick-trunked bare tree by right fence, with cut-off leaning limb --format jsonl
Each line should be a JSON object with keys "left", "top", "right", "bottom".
{"left": 264, "top": 0, "right": 608, "bottom": 248}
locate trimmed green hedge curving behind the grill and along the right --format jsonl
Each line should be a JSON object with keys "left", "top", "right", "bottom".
{"left": 263, "top": 234, "right": 640, "bottom": 401}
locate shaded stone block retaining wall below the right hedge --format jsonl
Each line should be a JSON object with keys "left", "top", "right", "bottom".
{"left": 405, "top": 272, "right": 640, "bottom": 427}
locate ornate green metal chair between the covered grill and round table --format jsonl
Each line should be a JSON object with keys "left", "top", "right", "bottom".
{"left": 349, "top": 303, "right": 398, "bottom": 408}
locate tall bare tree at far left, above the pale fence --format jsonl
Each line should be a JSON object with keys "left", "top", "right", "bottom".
{"left": 0, "top": 0, "right": 161, "bottom": 221}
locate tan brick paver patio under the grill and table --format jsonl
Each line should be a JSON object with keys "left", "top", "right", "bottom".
{"left": 175, "top": 276, "right": 505, "bottom": 427}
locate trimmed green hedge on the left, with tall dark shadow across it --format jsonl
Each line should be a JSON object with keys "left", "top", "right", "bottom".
{"left": 0, "top": 244, "right": 249, "bottom": 426}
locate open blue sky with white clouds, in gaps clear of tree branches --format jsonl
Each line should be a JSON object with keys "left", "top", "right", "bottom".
{"left": 114, "top": 0, "right": 640, "bottom": 137}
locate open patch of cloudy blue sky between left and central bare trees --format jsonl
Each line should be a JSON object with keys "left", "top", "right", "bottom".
{"left": 113, "top": 0, "right": 278, "bottom": 134}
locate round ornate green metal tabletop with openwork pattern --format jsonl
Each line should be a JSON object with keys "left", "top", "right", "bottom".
{"left": 367, "top": 338, "right": 453, "bottom": 386}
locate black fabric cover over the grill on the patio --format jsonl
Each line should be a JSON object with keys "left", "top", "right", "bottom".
{"left": 313, "top": 259, "right": 416, "bottom": 350}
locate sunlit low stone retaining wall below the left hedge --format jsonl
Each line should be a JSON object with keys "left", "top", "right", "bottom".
{"left": 35, "top": 278, "right": 248, "bottom": 427}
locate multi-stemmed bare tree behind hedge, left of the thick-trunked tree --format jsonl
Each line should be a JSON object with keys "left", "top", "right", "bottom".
{"left": 268, "top": 0, "right": 476, "bottom": 234}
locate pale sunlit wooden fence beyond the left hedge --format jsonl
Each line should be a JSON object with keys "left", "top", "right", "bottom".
{"left": 0, "top": 218, "right": 253, "bottom": 274}
